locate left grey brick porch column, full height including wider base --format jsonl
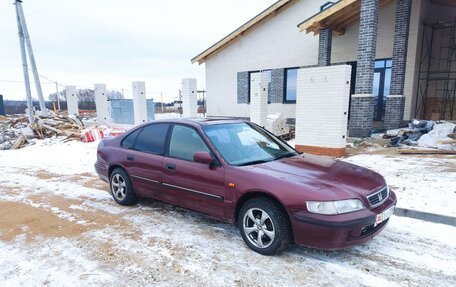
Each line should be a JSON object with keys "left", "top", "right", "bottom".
{"left": 349, "top": 0, "right": 379, "bottom": 137}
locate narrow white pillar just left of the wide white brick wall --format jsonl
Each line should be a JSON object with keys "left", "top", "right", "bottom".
{"left": 250, "top": 72, "right": 269, "bottom": 127}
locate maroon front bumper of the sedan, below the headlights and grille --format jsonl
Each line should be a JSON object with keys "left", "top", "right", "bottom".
{"left": 292, "top": 191, "right": 396, "bottom": 249}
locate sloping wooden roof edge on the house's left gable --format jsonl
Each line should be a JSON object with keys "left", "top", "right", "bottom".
{"left": 192, "top": 0, "right": 293, "bottom": 64}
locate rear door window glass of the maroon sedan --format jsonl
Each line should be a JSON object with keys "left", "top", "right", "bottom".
{"left": 135, "top": 123, "right": 169, "bottom": 154}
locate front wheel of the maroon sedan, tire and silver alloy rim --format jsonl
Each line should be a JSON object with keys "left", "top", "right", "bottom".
{"left": 238, "top": 197, "right": 292, "bottom": 255}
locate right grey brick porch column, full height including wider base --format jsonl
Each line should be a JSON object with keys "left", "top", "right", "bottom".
{"left": 384, "top": 0, "right": 412, "bottom": 129}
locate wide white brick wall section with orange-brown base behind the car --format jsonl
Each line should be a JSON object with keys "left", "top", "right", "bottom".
{"left": 296, "top": 65, "right": 351, "bottom": 155}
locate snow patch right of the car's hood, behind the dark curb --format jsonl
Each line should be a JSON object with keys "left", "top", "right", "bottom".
{"left": 345, "top": 154, "right": 456, "bottom": 217}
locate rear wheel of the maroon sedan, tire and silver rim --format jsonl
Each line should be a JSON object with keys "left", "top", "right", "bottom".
{"left": 109, "top": 168, "right": 138, "bottom": 205}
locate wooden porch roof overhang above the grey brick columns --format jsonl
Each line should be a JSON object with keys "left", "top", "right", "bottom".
{"left": 298, "top": 0, "right": 392, "bottom": 35}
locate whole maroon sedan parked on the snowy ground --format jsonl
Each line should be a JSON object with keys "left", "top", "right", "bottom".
{"left": 95, "top": 118, "right": 396, "bottom": 255}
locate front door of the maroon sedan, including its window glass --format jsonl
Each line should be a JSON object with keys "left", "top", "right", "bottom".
{"left": 163, "top": 124, "right": 225, "bottom": 219}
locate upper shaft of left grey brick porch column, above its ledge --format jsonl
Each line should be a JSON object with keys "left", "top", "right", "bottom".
{"left": 355, "top": 0, "right": 379, "bottom": 94}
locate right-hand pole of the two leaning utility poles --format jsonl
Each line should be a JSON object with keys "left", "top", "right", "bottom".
{"left": 15, "top": 0, "right": 49, "bottom": 116}
